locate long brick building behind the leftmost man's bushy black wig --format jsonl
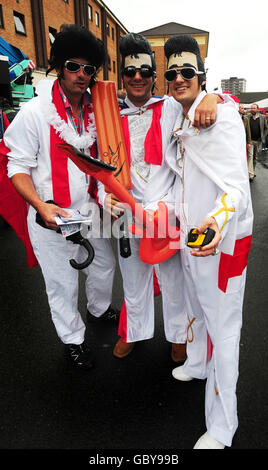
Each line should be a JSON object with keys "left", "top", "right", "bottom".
{"left": 0, "top": 0, "right": 128, "bottom": 88}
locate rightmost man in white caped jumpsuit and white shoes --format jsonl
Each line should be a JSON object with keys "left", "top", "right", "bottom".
{"left": 165, "top": 35, "right": 253, "bottom": 449}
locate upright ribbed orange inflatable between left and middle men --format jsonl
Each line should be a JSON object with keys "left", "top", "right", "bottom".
{"left": 91, "top": 81, "right": 132, "bottom": 189}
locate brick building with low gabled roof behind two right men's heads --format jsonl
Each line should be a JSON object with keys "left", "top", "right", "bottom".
{"left": 140, "top": 23, "right": 209, "bottom": 96}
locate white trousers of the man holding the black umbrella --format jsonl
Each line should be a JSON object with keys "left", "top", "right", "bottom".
{"left": 27, "top": 208, "right": 115, "bottom": 344}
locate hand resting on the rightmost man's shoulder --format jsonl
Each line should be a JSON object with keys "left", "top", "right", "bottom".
{"left": 193, "top": 94, "right": 222, "bottom": 129}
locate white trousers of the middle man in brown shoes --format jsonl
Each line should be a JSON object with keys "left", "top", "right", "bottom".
{"left": 118, "top": 238, "right": 187, "bottom": 343}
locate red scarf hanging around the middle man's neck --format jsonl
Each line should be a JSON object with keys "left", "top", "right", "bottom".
{"left": 122, "top": 101, "right": 163, "bottom": 166}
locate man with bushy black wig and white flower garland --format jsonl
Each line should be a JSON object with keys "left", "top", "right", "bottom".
{"left": 1, "top": 25, "right": 115, "bottom": 368}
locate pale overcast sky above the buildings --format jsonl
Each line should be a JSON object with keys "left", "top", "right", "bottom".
{"left": 104, "top": 0, "right": 268, "bottom": 92}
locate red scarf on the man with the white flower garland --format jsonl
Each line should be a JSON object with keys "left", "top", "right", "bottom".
{"left": 50, "top": 80, "right": 97, "bottom": 207}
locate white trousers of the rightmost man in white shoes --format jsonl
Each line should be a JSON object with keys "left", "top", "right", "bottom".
{"left": 181, "top": 249, "right": 246, "bottom": 446}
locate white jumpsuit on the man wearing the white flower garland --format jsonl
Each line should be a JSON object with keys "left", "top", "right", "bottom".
{"left": 4, "top": 80, "right": 115, "bottom": 344}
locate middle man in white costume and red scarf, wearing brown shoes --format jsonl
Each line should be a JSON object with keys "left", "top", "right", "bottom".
{"left": 99, "top": 33, "right": 222, "bottom": 362}
